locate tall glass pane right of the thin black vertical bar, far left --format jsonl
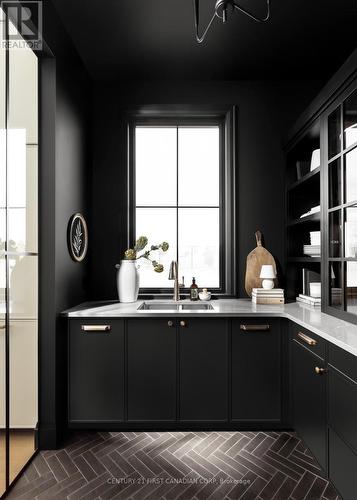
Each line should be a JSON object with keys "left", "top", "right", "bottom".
{"left": 7, "top": 28, "right": 38, "bottom": 483}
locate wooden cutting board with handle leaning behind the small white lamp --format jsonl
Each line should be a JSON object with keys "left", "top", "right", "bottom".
{"left": 245, "top": 231, "right": 276, "bottom": 297}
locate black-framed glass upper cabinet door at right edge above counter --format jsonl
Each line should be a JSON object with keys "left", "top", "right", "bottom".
{"left": 326, "top": 86, "right": 357, "bottom": 315}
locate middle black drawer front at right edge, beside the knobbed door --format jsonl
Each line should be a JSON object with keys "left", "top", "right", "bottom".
{"left": 328, "top": 366, "right": 357, "bottom": 453}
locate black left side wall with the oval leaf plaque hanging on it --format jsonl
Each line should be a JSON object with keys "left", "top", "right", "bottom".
{"left": 39, "top": 1, "right": 92, "bottom": 448}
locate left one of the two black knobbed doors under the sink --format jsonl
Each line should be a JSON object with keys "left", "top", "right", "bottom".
{"left": 127, "top": 318, "right": 177, "bottom": 422}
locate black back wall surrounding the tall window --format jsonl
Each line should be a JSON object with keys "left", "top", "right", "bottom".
{"left": 90, "top": 81, "right": 321, "bottom": 300}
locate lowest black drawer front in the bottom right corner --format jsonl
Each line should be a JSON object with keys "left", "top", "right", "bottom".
{"left": 329, "top": 429, "right": 357, "bottom": 500}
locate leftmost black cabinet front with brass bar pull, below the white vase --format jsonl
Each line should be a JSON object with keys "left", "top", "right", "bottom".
{"left": 69, "top": 319, "right": 124, "bottom": 423}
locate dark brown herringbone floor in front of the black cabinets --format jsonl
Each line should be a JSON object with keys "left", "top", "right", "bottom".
{"left": 8, "top": 432, "right": 338, "bottom": 500}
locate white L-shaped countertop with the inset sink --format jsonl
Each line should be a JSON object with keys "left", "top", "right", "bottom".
{"left": 62, "top": 299, "right": 357, "bottom": 356}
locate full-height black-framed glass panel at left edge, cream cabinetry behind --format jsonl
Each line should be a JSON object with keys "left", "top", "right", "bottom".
{"left": 0, "top": 5, "right": 39, "bottom": 496}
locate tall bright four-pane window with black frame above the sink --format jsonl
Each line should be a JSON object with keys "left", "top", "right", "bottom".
{"left": 131, "top": 119, "right": 225, "bottom": 291}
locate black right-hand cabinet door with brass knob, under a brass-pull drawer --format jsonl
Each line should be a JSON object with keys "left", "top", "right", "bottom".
{"left": 292, "top": 340, "right": 326, "bottom": 468}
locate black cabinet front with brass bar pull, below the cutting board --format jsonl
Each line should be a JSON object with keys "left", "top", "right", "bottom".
{"left": 232, "top": 318, "right": 282, "bottom": 422}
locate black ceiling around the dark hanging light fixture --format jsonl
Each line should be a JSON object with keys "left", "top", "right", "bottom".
{"left": 49, "top": 0, "right": 357, "bottom": 80}
